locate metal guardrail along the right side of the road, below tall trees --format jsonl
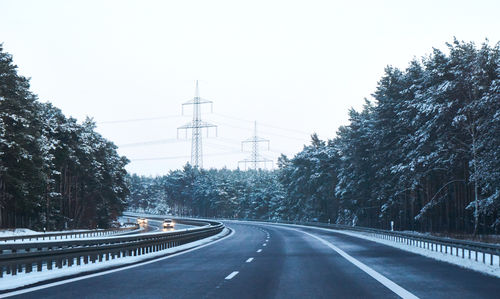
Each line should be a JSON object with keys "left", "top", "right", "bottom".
{"left": 246, "top": 219, "right": 500, "bottom": 267}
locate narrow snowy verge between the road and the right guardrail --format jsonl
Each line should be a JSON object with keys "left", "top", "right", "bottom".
{"left": 259, "top": 222, "right": 500, "bottom": 278}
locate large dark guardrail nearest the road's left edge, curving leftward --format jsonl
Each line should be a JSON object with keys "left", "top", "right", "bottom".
{"left": 0, "top": 219, "right": 224, "bottom": 278}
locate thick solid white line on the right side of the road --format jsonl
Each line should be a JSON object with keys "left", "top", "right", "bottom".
{"left": 285, "top": 228, "right": 418, "bottom": 299}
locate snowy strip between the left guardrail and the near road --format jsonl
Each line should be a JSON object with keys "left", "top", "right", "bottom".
{"left": 0, "top": 228, "right": 229, "bottom": 297}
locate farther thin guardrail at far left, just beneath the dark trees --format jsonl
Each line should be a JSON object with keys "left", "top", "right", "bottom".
{"left": 0, "top": 224, "right": 139, "bottom": 244}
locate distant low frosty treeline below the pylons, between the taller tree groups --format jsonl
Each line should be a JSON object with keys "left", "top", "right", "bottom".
{"left": 128, "top": 164, "right": 284, "bottom": 219}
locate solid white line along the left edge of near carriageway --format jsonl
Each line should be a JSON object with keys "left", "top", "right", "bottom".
{"left": 0, "top": 228, "right": 236, "bottom": 298}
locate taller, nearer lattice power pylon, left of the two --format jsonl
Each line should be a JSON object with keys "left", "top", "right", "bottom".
{"left": 177, "top": 80, "right": 217, "bottom": 168}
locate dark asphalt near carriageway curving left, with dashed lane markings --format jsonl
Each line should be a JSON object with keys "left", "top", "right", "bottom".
{"left": 7, "top": 222, "right": 500, "bottom": 299}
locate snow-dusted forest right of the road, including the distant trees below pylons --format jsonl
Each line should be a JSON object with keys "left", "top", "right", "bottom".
{"left": 127, "top": 39, "right": 500, "bottom": 234}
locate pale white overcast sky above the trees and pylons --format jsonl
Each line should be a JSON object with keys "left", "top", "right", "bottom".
{"left": 0, "top": 0, "right": 500, "bottom": 175}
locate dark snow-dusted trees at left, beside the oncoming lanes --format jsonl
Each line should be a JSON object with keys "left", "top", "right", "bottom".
{"left": 0, "top": 44, "right": 128, "bottom": 230}
